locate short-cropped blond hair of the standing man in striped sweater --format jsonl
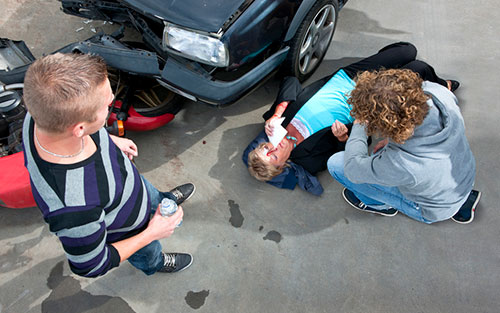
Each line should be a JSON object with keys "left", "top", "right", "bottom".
{"left": 24, "top": 53, "right": 107, "bottom": 133}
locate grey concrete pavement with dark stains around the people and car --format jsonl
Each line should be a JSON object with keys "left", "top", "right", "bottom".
{"left": 0, "top": 0, "right": 500, "bottom": 313}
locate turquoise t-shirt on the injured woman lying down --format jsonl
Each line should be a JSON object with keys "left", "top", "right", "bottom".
{"left": 294, "top": 70, "right": 355, "bottom": 135}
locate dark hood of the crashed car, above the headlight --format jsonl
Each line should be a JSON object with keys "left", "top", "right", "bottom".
{"left": 123, "top": 0, "right": 249, "bottom": 33}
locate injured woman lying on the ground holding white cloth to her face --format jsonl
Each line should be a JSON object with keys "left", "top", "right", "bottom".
{"left": 243, "top": 42, "right": 458, "bottom": 195}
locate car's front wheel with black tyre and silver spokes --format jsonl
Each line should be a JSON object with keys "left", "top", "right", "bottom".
{"left": 283, "top": 0, "right": 338, "bottom": 82}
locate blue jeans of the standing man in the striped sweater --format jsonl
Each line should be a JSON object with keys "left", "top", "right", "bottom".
{"left": 128, "top": 175, "right": 175, "bottom": 275}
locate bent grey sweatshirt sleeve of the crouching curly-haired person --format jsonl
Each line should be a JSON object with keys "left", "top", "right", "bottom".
{"left": 344, "top": 124, "right": 415, "bottom": 186}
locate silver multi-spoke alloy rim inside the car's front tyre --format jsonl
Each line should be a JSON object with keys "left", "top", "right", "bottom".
{"left": 298, "top": 4, "right": 336, "bottom": 75}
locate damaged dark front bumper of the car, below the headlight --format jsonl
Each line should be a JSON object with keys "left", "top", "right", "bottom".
{"left": 58, "top": 35, "right": 289, "bottom": 106}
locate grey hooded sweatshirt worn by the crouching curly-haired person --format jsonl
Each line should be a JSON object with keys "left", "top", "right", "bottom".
{"left": 344, "top": 81, "right": 476, "bottom": 222}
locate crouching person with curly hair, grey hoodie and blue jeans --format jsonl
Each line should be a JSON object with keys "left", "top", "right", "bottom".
{"left": 328, "top": 69, "right": 481, "bottom": 223}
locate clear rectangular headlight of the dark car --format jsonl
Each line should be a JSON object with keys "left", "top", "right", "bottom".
{"left": 163, "top": 23, "right": 229, "bottom": 67}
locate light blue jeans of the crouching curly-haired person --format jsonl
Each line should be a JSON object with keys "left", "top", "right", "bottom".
{"left": 328, "top": 151, "right": 433, "bottom": 224}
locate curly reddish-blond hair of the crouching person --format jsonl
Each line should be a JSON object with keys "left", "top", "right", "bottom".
{"left": 347, "top": 69, "right": 429, "bottom": 144}
